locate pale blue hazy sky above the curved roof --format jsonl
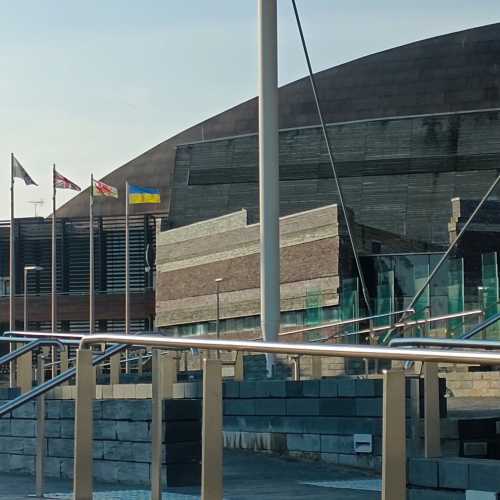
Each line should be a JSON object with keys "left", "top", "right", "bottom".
{"left": 0, "top": 0, "right": 500, "bottom": 219}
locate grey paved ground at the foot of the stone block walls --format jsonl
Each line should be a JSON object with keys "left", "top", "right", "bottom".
{"left": 0, "top": 451, "right": 380, "bottom": 500}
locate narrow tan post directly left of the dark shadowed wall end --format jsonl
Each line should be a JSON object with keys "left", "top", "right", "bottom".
{"left": 151, "top": 349, "right": 165, "bottom": 500}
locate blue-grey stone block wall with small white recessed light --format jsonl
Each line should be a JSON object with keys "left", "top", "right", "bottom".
{"left": 174, "top": 377, "right": 450, "bottom": 470}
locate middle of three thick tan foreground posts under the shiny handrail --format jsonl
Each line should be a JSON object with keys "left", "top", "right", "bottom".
{"left": 201, "top": 358, "right": 224, "bottom": 500}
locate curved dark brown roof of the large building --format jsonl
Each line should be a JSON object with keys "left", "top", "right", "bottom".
{"left": 58, "top": 23, "right": 500, "bottom": 217}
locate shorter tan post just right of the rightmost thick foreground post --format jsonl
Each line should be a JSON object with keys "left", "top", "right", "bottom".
{"left": 423, "top": 363, "right": 441, "bottom": 458}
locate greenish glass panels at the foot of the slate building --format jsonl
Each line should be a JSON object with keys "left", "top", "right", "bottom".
{"left": 163, "top": 252, "right": 500, "bottom": 343}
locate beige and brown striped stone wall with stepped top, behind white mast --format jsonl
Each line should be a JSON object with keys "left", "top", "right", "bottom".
{"left": 156, "top": 205, "right": 341, "bottom": 327}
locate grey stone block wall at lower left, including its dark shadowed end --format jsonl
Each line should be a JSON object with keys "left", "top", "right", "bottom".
{"left": 0, "top": 399, "right": 201, "bottom": 486}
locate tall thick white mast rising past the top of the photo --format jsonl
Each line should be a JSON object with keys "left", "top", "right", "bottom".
{"left": 258, "top": 0, "right": 280, "bottom": 376}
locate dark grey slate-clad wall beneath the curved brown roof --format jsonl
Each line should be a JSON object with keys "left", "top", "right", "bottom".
{"left": 170, "top": 111, "right": 500, "bottom": 245}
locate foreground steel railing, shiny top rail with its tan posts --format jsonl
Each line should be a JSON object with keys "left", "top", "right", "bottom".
{"left": 70, "top": 334, "right": 500, "bottom": 500}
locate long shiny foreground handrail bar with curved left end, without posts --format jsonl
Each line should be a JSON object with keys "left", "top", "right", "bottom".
{"left": 78, "top": 333, "right": 500, "bottom": 366}
